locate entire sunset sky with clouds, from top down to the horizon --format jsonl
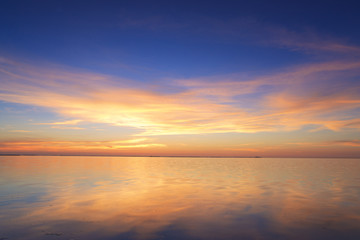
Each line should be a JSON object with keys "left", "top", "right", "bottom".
{"left": 0, "top": 0, "right": 360, "bottom": 157}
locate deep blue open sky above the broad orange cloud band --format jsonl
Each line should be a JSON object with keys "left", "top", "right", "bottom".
{"left": 0, "top": 1, "right": 359, "bottom": 75}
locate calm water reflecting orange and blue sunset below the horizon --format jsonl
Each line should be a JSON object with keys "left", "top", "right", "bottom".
{"left": 0, "top": 156, "right": 360, "bottom": 240}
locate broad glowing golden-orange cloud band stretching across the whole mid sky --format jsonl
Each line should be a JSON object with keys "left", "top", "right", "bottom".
{"left": 0, "top": 56, "right": 360, "bottom": 135}
